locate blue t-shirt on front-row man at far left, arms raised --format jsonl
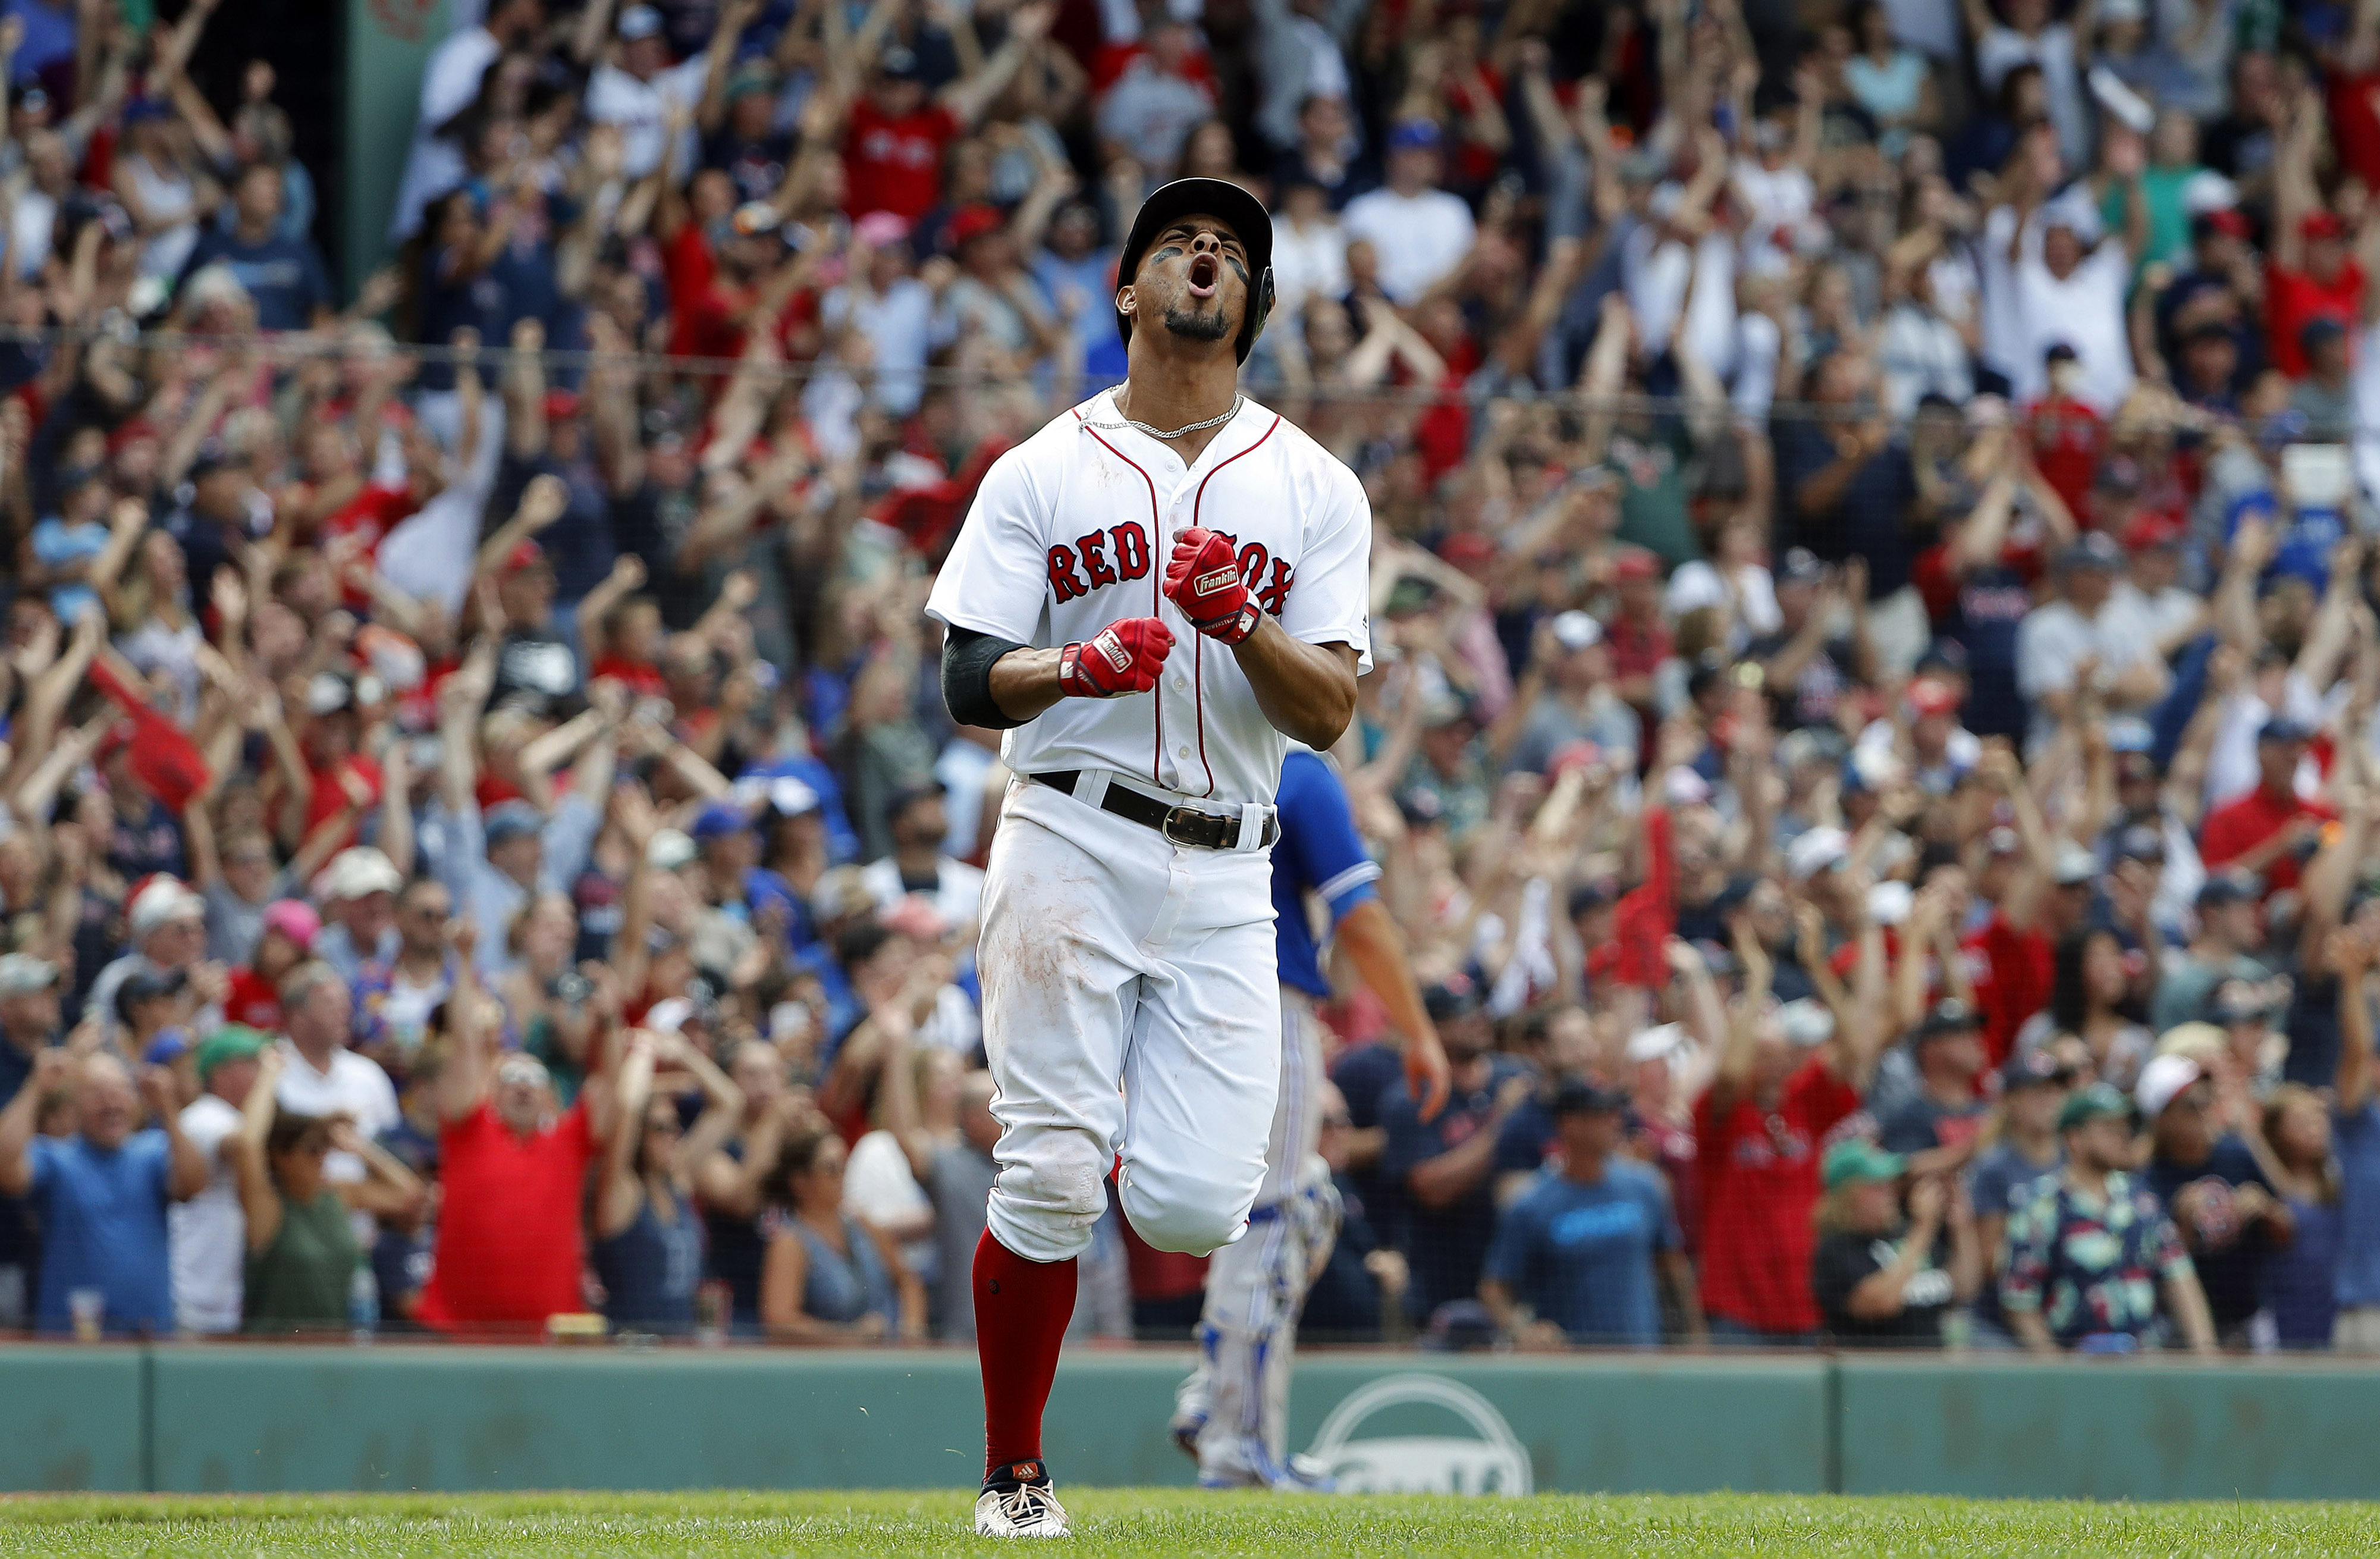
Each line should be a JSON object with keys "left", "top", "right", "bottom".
{"left": 29, "top": 1128, "right": 174, "bottom": 1333}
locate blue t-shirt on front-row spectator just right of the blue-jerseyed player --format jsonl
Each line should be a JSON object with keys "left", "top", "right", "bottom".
{"left": 1485, "top": 1157, "right": 1682, "bottom": 1345}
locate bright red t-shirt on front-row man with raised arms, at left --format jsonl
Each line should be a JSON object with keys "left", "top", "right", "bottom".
{"left": 416, "top": 1100, "right": 595, "bottom": 1331}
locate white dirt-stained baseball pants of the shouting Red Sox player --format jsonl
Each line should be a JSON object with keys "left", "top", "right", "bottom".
{"left": 976, "top": 778, "right": 1280, "bottom": 1262}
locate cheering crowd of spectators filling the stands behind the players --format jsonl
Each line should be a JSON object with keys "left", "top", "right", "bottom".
{"left": 0, "top": 0, "right": 2380, "bottom": 1352}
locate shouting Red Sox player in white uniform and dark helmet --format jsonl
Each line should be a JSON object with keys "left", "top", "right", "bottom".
{"left": 926, "top": 178, "right": 1437, "bottom": 1538}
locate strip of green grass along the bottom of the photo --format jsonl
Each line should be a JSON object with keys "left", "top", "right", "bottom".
{"left": 0, "top": 1490, "right": 2380, "bottom": 1559}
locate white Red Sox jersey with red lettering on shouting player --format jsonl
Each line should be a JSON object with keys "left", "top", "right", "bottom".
{"left": 926, "top": 390, "right": 1371, "bottom": 807}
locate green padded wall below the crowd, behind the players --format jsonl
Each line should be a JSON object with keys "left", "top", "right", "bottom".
{"left": 0, "top": 1342, "right": 2380, "bottom": 1500}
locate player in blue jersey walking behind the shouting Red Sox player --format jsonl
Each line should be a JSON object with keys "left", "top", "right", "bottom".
{"left": 1173, "top": 747, "right": 1445, "bottom": 1492}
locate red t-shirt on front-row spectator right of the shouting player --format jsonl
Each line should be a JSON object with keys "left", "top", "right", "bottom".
{"left": 1694, "top": 1057, "right": 1859, "bottom": 1333}
